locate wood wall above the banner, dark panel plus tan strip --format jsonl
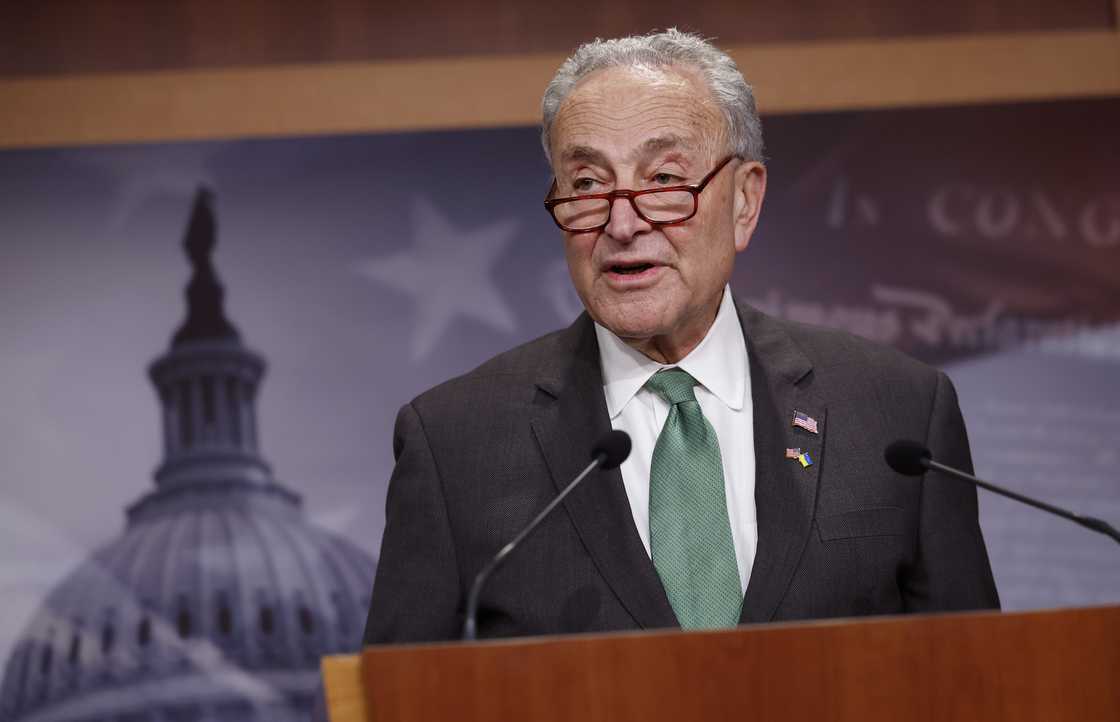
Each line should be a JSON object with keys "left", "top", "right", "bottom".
{"left": 0, "top": 0, "right": 1120, "bottom": 148}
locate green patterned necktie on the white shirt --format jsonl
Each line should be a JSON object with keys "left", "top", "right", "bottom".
{"left": 645, "top": 368, "right": 743, "bottom": 629}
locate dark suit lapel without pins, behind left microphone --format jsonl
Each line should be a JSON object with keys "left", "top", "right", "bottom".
{"left": 530, "top": 313, "right": 678, "bottom": 629}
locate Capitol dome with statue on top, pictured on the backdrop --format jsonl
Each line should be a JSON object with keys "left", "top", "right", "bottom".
{"left": 0, "top": 190, "right": 375, "bottom": 722}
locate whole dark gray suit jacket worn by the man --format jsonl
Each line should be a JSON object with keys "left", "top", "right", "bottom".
{"left": 365, "top": 303, "right": 999, "bottom": 644}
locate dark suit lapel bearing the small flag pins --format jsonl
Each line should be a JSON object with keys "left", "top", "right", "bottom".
{"left": 739, "top": 304, "right": 825, "bottom": 623}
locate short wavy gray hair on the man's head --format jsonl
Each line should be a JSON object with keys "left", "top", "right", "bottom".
{"left": 541, "top": 28, "right": 763, "bottom": 162}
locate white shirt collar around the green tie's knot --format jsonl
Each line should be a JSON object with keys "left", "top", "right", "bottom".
{"left": 595, "top": 287, "right": 748, "bottom": 419}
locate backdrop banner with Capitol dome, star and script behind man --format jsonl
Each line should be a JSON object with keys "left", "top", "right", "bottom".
{"left": 0, "top": 100, "right": 1120, "bottom": 721}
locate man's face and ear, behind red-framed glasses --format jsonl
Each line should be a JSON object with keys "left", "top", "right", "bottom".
{"left": 551, "top": 68, "right": 766, "bottom": 360}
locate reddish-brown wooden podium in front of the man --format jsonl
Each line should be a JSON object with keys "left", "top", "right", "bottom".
{"left": 323, "top": 607, "right": 1120, "bottom": 722}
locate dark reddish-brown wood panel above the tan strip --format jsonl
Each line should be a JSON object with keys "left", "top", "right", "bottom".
{"left": 0, "top": 0, "right": 1116, "bottom": 75}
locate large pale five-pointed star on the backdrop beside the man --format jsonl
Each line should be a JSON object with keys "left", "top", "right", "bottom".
{"left": 357, "top": 198, "right": 519, "bottom": 360}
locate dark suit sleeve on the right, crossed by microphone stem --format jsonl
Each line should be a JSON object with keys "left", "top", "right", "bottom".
{"left": 903, "top": 372, "right": 999, "bottom": 612}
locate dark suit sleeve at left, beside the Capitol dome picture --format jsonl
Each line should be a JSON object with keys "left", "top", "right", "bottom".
{"left": 363, "top": 404, "right": 461, "bottom": 645}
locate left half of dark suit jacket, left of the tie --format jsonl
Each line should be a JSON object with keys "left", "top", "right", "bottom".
{"left": 365, "top": 315, "right": 658, "bottom": 643}
